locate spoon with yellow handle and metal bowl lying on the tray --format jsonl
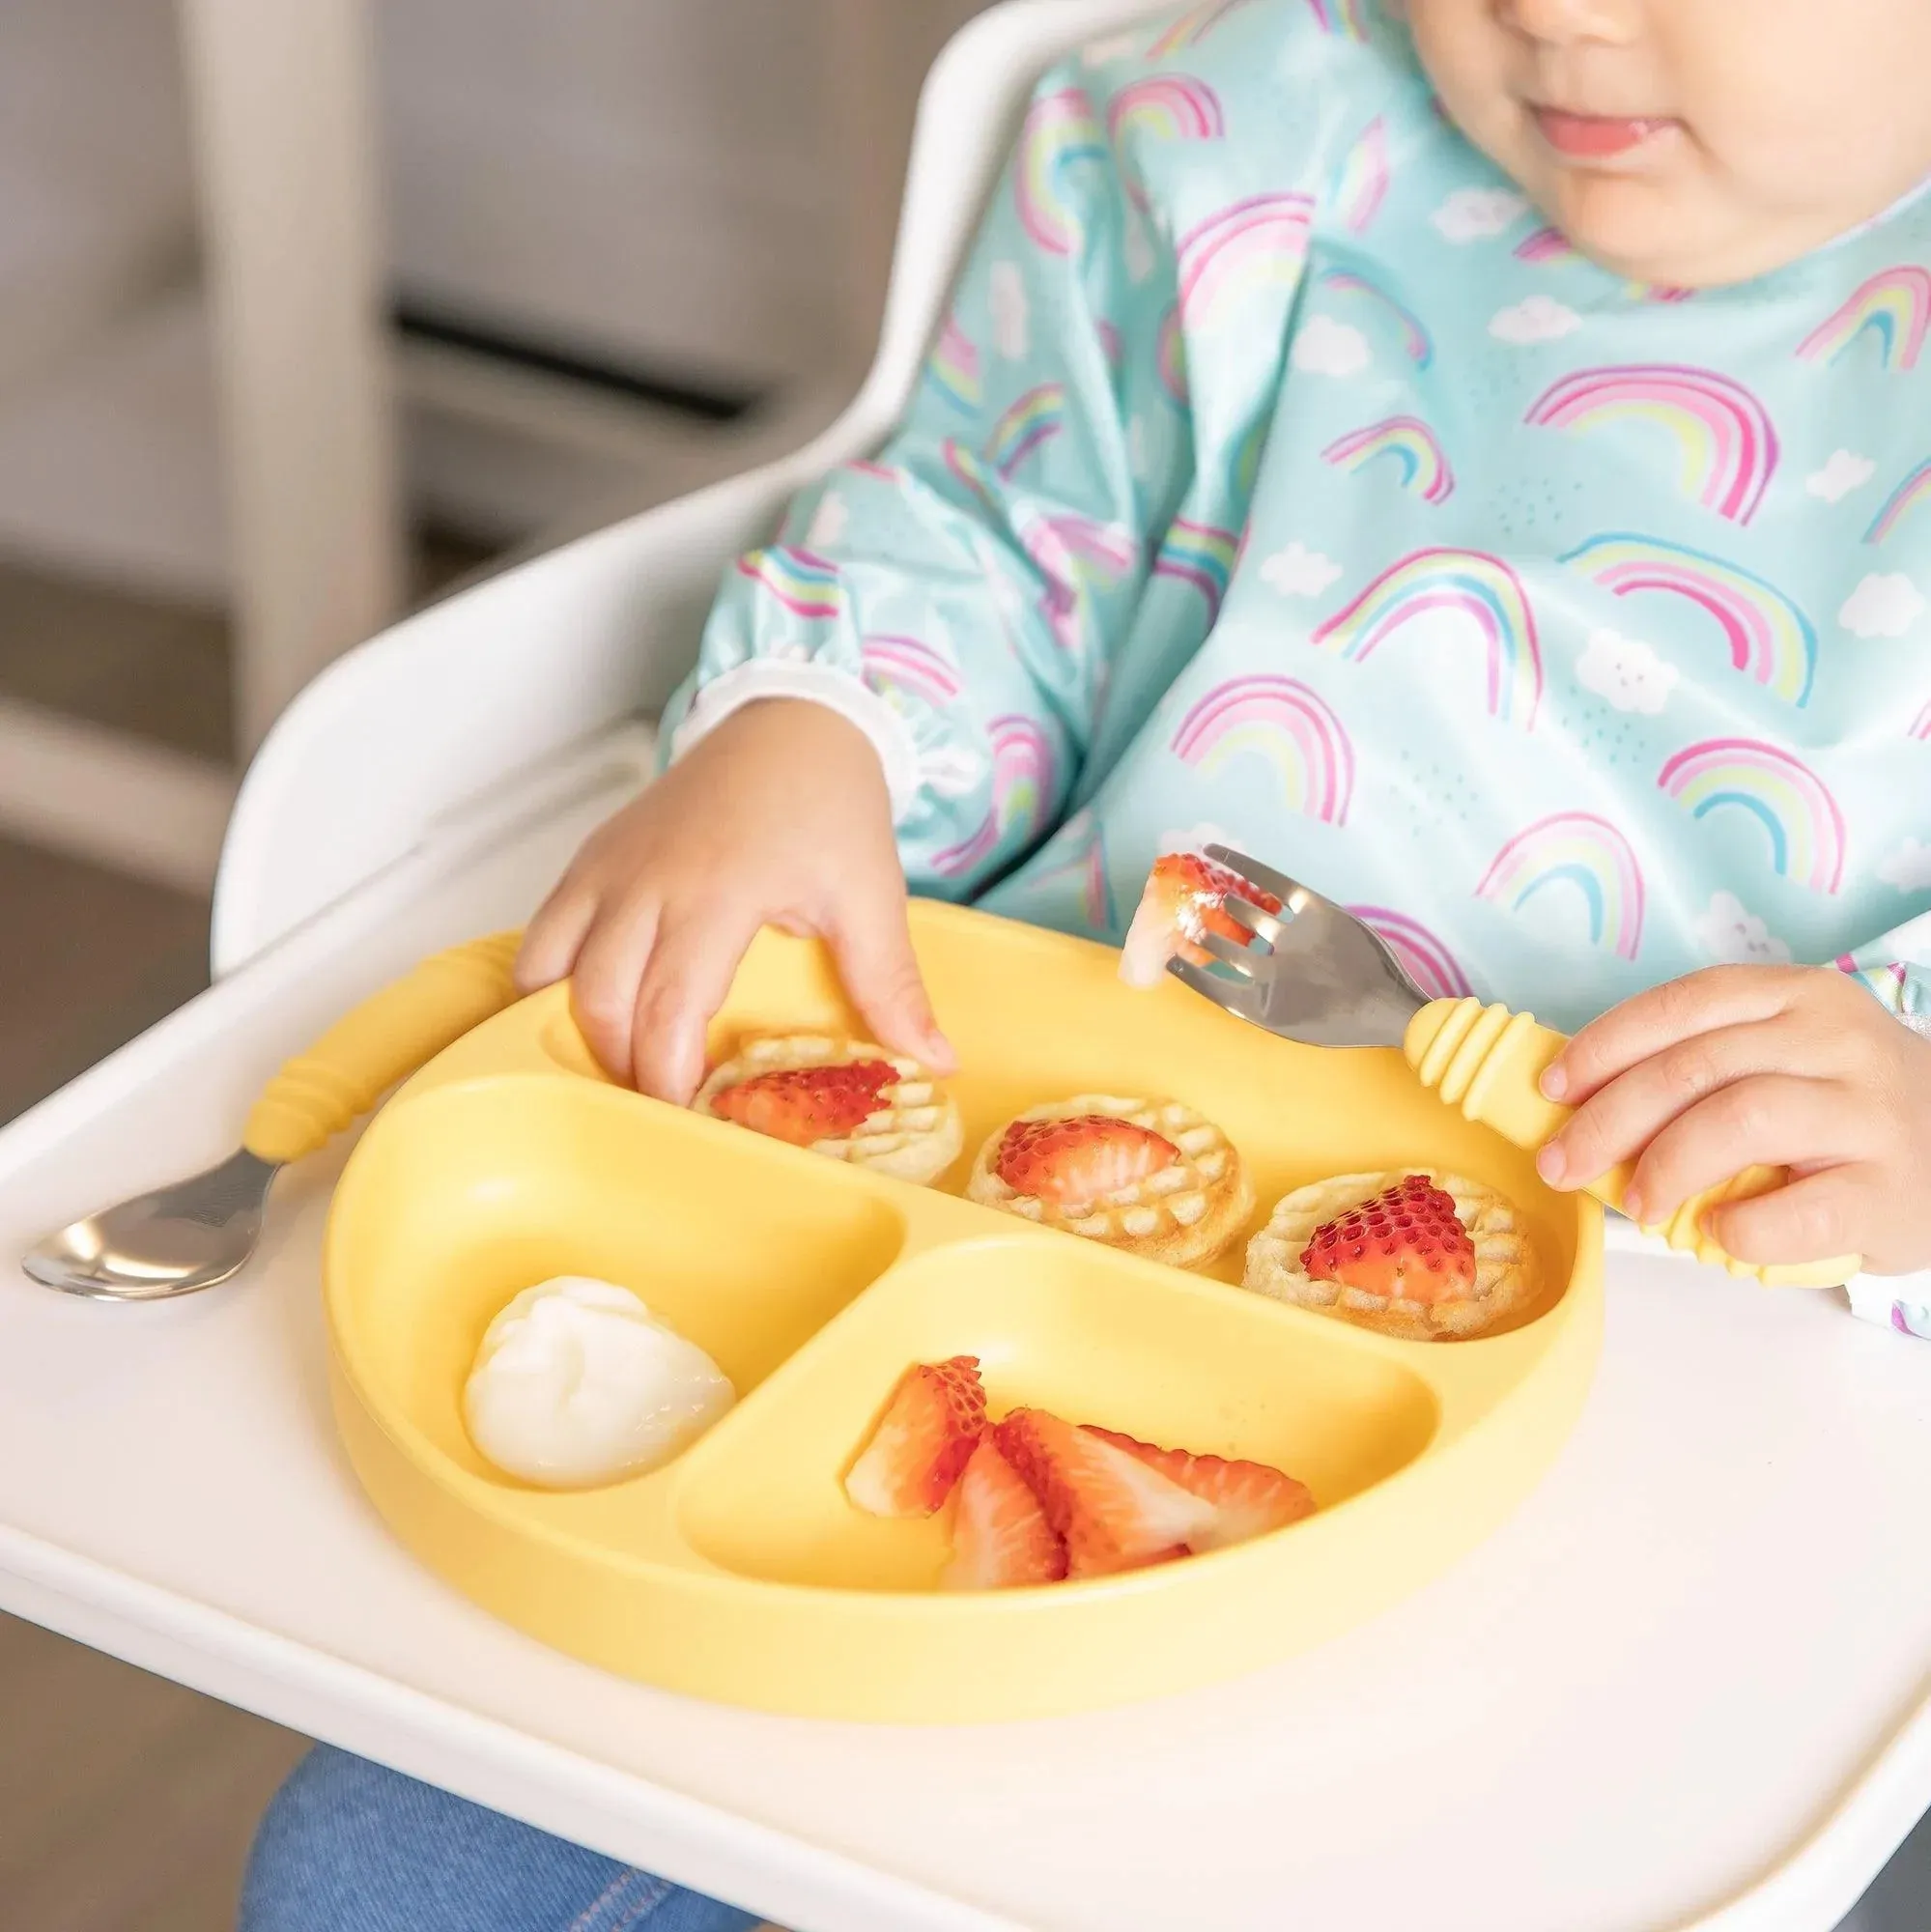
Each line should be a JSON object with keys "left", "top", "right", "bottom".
{"left": 21, "top": 933, "right": 522, "bottom": 1302}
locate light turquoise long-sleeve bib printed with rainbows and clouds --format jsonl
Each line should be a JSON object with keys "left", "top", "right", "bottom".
{"left": 672, "top": 0, "right": 1931, "bottom": 1028}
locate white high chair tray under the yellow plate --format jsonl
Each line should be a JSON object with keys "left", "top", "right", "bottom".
{"left": 0, "top": 742, "right": 1931, "bottom": 1932}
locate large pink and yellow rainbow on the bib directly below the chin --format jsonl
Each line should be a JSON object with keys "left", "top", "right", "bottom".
{"left": 1527, "top": 363, "right": 1776, "bottom": 524}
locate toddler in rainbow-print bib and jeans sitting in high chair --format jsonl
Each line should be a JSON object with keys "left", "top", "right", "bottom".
{"left": 237, "top": 0, "right": 1931, "bottom": 1932}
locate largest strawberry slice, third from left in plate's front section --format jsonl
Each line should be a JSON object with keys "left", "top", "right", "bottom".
{"left": 992, "top": 1408, "right": 1214, "bottom": 1577}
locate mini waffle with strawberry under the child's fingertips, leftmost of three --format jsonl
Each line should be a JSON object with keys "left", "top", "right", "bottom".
{"left": 692, "top": 1034, "right": 964, "bottom": 1186}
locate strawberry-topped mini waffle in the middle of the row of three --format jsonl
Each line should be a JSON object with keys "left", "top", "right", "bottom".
{"left": 966, "top": 1094, "right": 1253, "bottom": 1267}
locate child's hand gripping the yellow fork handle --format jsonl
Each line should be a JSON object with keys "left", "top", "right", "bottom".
{"left": 1539, "top": 966, "right": 1931, "bottom": 1275}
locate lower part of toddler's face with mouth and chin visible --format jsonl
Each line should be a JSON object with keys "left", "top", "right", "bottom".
{"left": 1406, "top": 0, "right": 1931, "bottom": 288}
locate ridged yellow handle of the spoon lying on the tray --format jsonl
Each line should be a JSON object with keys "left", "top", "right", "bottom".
{"left": 241, "top": 933, "right": 524, "bottom": 1165}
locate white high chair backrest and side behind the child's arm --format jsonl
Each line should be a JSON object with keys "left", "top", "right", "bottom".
{"left": 213, "top": 0, "right": 1160, "bottom": 974}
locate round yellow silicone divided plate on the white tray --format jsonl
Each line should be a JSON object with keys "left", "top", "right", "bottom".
{"left": 325, "top": 902, "right": 1601, "bottom": 1721}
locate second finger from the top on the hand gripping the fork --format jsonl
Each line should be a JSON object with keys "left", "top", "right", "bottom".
{"left": 1537, "top": 1020, "right": 1832, "bottom": 1188}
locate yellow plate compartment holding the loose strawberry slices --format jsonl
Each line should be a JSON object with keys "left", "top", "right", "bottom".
{"left": 680, "top": 1236, "right": 1436, "bottom": 1590}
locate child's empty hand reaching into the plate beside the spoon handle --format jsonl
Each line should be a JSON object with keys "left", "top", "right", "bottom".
{"left": 516, "top": 699, "right": 954, "bottom": 1105}
